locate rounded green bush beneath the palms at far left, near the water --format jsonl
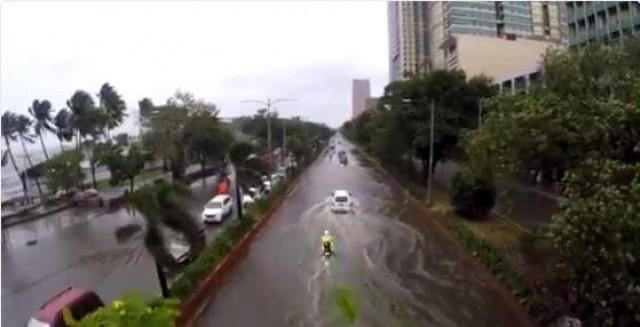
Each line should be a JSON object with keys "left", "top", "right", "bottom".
{"left": 46, "top": 151, "right": 85, "bottom": 192}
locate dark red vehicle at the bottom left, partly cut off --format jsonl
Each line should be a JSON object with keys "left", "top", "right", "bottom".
{"left": 26, "top": 287, "right": 104, "bottom": 327}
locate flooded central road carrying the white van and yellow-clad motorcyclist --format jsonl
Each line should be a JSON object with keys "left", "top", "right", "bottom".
{"left": 196, "top": 140, "right": 530, "bottom": 327}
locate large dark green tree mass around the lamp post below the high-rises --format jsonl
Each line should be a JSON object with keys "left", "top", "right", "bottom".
{"left": 344, "top": 70, "right": 495, "bottom": 181}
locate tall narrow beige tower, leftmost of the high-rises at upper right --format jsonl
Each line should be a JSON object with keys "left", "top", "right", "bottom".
{"left": 387, "top": 1, "right": 429, "bottom": 80}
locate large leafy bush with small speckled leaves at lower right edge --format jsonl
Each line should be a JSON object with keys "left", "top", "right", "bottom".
{"left": 550, "top": 160, "right": 640, "bottom": 326}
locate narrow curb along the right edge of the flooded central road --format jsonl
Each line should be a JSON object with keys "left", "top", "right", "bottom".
{"left": 349, "top": 145, "right": 537, "bottom": 327}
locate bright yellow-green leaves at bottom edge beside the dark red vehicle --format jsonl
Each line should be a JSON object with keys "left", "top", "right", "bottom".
{"left": 63, "top": 295, "right": 179, "bottom": 327}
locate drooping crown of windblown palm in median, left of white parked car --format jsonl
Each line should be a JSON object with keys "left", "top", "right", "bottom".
{"left": 126, "top": 179, "right": 205, "bottom": 269}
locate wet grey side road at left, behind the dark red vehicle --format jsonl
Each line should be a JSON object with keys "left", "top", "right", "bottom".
{"left": 2, "top": 177, "right": 233, "bottom": 327}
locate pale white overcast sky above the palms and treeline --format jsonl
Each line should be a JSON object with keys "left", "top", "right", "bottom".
{"left": 0, "top": 1, "right": 388, "bottom": 148}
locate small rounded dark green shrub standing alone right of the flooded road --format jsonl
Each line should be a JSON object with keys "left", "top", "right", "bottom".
{"left": 451, "top": 170, "right": 496, "bottom": 218}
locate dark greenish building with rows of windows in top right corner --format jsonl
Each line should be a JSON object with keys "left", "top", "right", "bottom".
{"left": 566, "top": 1, "right": 640, "bottom": 46}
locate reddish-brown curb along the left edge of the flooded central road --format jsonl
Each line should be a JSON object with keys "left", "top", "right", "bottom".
{"left": 176, "top": 152, "right": 323, "bottom": 327}
